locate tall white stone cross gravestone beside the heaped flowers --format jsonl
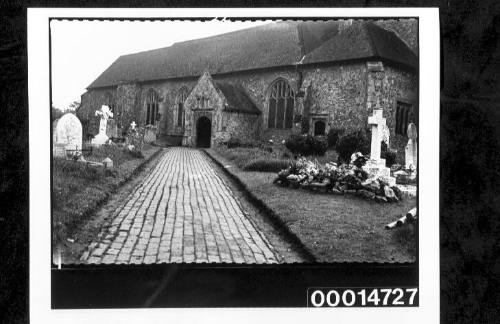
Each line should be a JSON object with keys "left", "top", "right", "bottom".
{"left": 363, "top": 109, "right": 396, "bottom": 186}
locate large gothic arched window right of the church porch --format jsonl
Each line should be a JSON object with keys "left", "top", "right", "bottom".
{"left": 267, "top": 79, "right": 295, "bottom": 129}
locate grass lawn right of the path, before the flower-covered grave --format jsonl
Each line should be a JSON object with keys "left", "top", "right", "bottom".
{"left": 205, "top": 150, "right": 416, "bottom": 262}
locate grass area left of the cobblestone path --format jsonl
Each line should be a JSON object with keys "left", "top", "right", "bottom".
{"left": 52, "top": 145, "right": 159, "bottom": 246}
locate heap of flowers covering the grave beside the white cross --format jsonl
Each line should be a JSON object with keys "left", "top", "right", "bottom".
{"left": 274, "top": 152, "right": 402, "bottom": 202}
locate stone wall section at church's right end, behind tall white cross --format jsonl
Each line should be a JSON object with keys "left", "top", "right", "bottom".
{"left": 303, "top": 62, "right": 418, "bottom": 161}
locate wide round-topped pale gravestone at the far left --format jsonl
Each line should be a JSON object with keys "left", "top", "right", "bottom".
{"left": 52, "top": 113, "right": 82, "bottom": 157}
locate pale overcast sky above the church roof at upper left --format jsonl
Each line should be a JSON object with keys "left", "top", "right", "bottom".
{"left": 50, "top": 20, "right": 270, "bottom": 110}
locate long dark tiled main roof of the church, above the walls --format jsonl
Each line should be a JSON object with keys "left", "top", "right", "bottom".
{"left": 88, "top": 21, "right": 417, "bottom": 89}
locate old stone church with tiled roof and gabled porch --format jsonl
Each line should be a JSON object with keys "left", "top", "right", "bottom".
{"left": 77, "top": 19, "right": 418, "bottom": 153}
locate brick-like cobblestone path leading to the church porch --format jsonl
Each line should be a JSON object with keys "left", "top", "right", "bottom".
{"left": 81, "top": 147, "right": 278, "bottom": 264}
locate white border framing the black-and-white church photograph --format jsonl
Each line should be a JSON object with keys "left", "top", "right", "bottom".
{"left": 28, "top": 8, "right": 440, "bottom": 323}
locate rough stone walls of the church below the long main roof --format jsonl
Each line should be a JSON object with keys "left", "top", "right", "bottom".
{"left": 81, "top": 62, "right": 417, "bottom": 157}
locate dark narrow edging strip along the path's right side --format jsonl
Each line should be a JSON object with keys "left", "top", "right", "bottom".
{"left": 202, "top": 149, "right": 318, "bottom": 264}
